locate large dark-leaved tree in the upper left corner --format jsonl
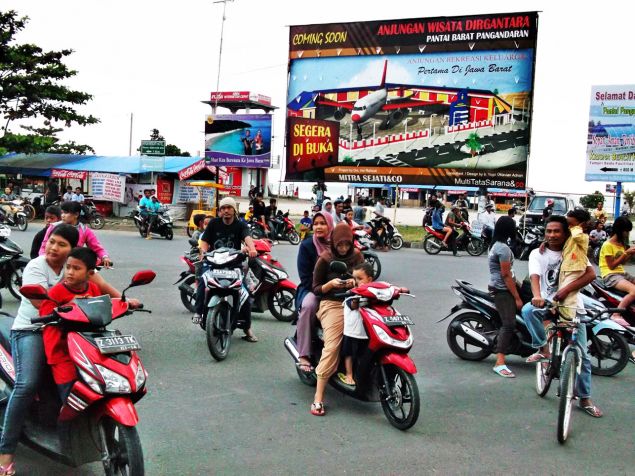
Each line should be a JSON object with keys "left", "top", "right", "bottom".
{"left": 0, "top": 10, "right": 99, "bottom": 154}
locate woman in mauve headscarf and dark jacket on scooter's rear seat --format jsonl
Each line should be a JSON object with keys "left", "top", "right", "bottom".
{"left": 296, "top": 212, "right": 333, "bottom": 373}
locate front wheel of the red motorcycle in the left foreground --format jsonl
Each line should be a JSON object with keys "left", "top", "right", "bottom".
{"left": 98, "top": 417, "right": 145, "bottom": 476}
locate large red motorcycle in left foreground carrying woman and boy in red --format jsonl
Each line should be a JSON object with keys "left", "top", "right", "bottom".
{"left": 0, "top": 270, "right": 155, "bottom": 475}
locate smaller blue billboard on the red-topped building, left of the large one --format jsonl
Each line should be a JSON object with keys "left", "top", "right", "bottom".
{"left": 205, "top": 114, "right": 271, "bottom": 168}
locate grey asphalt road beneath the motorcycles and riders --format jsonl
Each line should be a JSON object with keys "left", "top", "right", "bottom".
{"left": 2, "top": 229, "right": 635, "bottom": 476}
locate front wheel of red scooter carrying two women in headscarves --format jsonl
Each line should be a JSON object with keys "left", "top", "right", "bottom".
{"left": 380, "top": 365, "right": 421, "bottom": 430}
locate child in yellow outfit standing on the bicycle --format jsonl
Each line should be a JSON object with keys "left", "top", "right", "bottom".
{"left": 558, "top": 208, "right": 591, "bottom": 320}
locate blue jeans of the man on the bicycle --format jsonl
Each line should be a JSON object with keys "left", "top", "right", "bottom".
{"left": 521, "top": 303, "right": 591, "bottom": 398}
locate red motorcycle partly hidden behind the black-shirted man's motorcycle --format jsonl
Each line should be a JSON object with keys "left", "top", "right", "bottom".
{"left": 174, "top": 240, "right": 298, "bottom": 322}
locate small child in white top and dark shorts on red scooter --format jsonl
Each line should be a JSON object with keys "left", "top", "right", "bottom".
{"left": 337, "top": 262, "right": 373, "bottom": 386}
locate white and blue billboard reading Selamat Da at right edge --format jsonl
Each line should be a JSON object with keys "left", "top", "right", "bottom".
{"left": 584, "top": 84, "right": 635, "bottom": 182}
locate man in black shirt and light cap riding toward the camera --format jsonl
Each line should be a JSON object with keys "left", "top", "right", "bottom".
{"left": 198, "top": 197, "right": 258, "bottom": 342}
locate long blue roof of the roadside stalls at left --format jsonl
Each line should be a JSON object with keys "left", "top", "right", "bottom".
{"left": 0, "top": 154, "right": 201, "bottom": 176}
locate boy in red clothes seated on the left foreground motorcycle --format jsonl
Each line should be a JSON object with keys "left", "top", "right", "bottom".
{"left": 40, "top": 247, "right": 103, "bottom": 401}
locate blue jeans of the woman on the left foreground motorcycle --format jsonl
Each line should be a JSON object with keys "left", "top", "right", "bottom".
{"left": 0, "top": 330, "right": 46, "bottom": 454}
